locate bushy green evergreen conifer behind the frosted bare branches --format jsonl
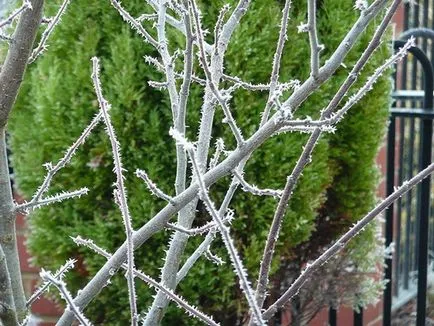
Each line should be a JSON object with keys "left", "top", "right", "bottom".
{"left": 10, "top": 0, "right": 389, "bottom": 324}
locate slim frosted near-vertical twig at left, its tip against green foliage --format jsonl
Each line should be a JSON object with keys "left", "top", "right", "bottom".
{"left": 92, "top": 57, "right": 138, "bottom": 326}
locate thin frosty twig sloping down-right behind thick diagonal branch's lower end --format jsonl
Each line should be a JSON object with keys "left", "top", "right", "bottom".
{"left": 72, "top": 236, "right": 219, "bottom": 326}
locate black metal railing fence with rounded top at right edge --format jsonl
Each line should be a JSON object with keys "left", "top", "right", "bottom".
{"left": 383, "top": 39, "right": 434, "bottom": 326}
